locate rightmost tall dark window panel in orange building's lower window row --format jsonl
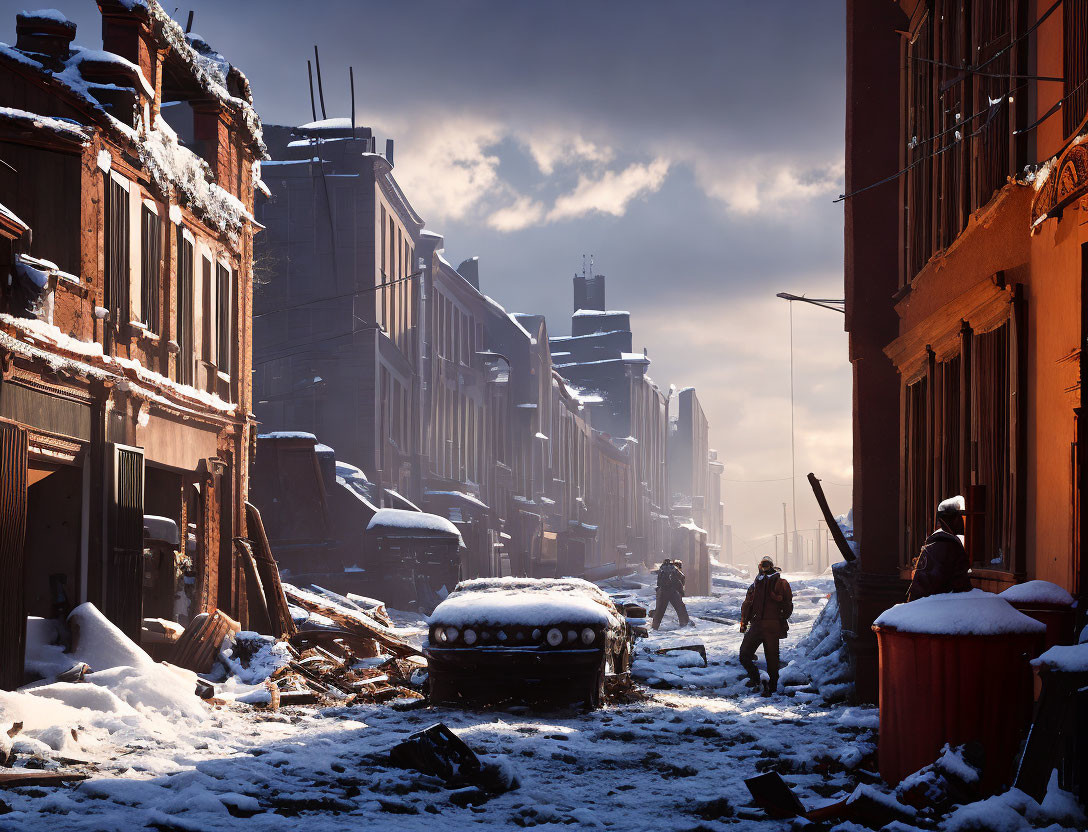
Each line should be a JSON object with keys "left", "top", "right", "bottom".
{"left": 972, "top": 322, "right": 1015, "bottom": 571}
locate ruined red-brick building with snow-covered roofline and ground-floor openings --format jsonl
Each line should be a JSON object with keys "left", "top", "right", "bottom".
{"left": 0, "top": 0, "right": 264, "bottom": 686}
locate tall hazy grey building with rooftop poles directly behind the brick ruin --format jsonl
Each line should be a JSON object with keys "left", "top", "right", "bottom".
{"left": 254, "top": 119, "right": 423, "bottom": 494}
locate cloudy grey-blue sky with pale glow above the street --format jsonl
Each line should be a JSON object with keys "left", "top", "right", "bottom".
{"left": 0, "top": 0, "right": 851, "bottom": 555}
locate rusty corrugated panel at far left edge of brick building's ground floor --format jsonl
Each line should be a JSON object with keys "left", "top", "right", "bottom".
{"left": 0, "top": 421, "right": 27, "bottom": 690}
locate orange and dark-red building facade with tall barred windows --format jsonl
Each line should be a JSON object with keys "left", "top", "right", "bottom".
{"left": 845, "top": 0, "right": 1088, "bottom": 696}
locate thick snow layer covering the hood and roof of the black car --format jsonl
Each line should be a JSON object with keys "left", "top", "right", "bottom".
{"left": 430, "top": 578, "right": 620, "bottom": 626}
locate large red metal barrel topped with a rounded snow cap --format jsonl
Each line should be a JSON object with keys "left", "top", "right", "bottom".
{"left": 873, "top": 589, "right": 1046, "bottom": 792}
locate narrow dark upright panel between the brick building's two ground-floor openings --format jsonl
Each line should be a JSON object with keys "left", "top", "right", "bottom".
{"left": 104, "top": 445, "right": 144, "bottom": 642}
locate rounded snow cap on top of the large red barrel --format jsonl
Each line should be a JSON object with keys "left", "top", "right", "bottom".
{"left": 874, "top": 589, "right": 1047, "bottom": 635}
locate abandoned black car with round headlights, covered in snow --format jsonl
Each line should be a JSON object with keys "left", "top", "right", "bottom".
{"left": 423, "top": 578, "right": 634, "bottom": 708}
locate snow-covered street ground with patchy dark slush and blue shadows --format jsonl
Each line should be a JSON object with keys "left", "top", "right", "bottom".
{"left": 0, "top": 575, "right": 877, "bottom": 831}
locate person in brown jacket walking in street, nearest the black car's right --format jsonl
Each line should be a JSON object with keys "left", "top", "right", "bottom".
{"left": 741, "top": 558, "right": 793, "bottom": 696}
